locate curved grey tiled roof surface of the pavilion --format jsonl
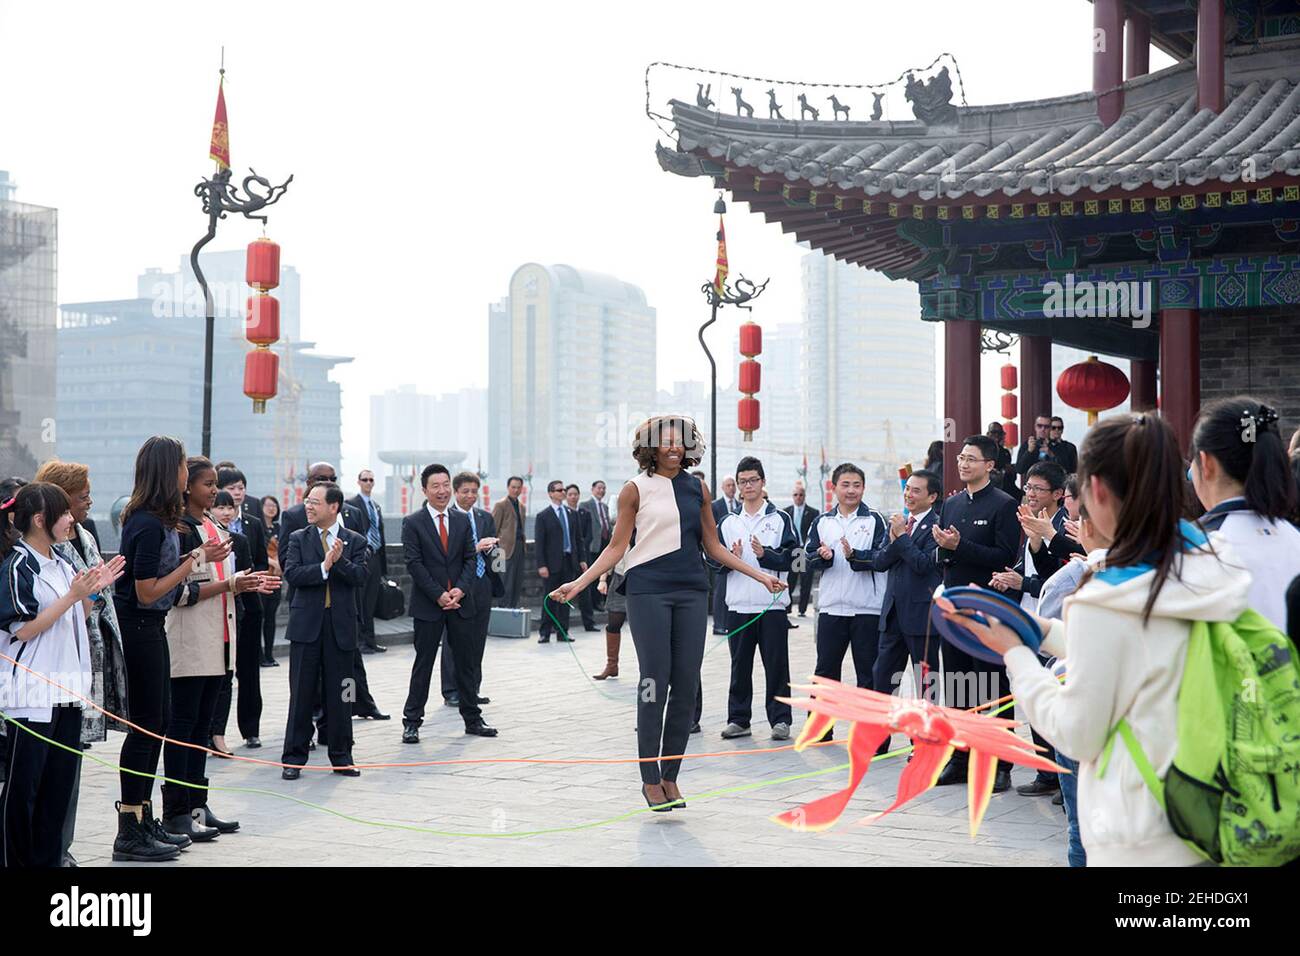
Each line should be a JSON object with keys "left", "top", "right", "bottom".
{"left": 671, "top": 40, "right": 1300, "bottom": 200}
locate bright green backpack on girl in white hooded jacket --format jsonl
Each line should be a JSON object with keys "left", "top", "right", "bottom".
{"left": 1097, "top": 610, "right": 1300, "bottom": 866}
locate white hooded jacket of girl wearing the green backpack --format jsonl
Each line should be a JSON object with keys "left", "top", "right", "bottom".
{"left": 1006, "top": 522, "right": 1251, "bottom": 866}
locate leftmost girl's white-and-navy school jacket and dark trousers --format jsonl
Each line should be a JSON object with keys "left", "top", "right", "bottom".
{"left": 0, "top": 541, "right": 91, "bottom": 866}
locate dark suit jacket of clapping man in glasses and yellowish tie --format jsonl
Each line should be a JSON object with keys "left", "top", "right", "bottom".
{"left": 281, "top": 527, "right": 371, "bottom": 650}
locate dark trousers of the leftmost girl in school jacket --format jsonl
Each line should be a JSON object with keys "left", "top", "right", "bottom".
{"left": 0, "top": 706, "right": 82, "bottom": 868}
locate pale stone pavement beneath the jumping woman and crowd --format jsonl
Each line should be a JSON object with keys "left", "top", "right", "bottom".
{"left": 65, "top": 614, "right": 1066, "bottom": 866}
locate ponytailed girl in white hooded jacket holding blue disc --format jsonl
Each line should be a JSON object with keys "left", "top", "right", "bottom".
{"left": 949, "top": 415, "right": 1251, "bottom": 866}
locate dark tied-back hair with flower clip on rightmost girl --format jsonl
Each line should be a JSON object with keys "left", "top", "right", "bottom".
{"left": 1192, "top": 395, "right": 1296, "bottom": 520}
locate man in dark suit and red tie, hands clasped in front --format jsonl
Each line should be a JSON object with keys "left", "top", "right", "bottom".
{"left": 402, "top": 464, "right": 497, "bottom": 744}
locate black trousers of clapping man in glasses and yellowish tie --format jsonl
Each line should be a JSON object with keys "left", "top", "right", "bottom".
{"left": 281, "top": 614, "right": 356, "bottom": 767}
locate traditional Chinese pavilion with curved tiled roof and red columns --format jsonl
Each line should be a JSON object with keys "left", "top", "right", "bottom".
{"left": 659, "top": 0, "right": 1300, "bottom": 484}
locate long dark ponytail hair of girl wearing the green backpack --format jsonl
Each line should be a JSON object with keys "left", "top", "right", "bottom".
{"left": 1079, "top": 414, "right": 1184, "bottom": 624}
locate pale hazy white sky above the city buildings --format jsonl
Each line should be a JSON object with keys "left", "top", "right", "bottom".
{"left": 0, "top": 0, "right": 1165, "bottom": 476}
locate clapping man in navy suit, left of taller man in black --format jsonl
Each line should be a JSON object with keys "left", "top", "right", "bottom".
{"left": 872, "top": 470, "right": 944, "bottom": 702}
